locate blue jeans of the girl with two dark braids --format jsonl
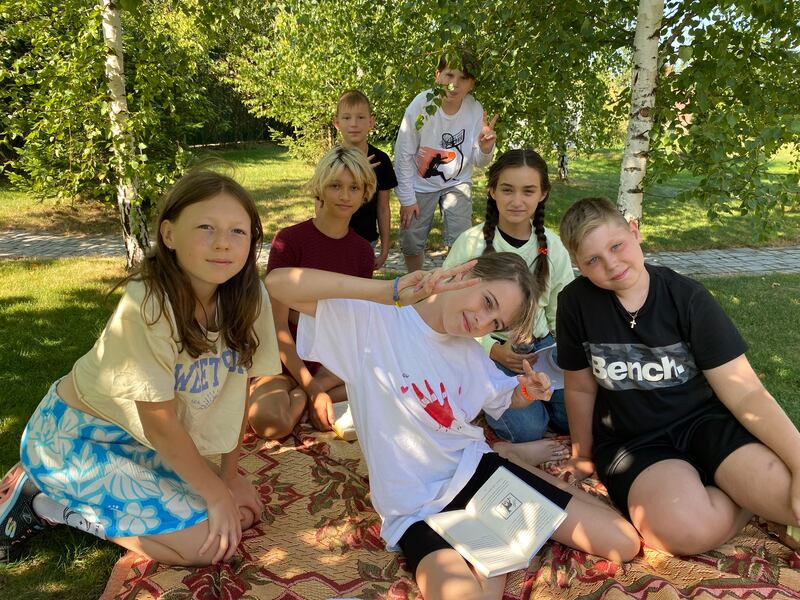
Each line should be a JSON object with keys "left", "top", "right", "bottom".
{"left": 486, "top": 335, "right": 569, "bottom": 442}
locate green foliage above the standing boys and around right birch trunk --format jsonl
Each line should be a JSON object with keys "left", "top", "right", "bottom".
{"left": 229, "top": 0, "right": 800, "bottom": 235}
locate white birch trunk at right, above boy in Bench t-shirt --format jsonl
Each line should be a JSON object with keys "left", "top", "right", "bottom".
{"left": 617, "top": 0, "right": 664, "bottom": 222}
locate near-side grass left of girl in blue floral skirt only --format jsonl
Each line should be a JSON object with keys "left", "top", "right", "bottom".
{"left": 0, "top": 259, "right": 123, "bottom": 600}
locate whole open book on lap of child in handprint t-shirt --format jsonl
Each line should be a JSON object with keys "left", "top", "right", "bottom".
{"left": 425, "top": 467, "right": 567, "bottom": 577}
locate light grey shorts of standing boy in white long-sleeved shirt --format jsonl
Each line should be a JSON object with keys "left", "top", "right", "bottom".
{"left": 398, "top": 183, "right": 472, "bottom": 256}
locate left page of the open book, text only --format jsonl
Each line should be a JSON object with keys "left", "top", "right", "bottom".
{"left": 425, "top": 510, "right": 527, "bottom": 575}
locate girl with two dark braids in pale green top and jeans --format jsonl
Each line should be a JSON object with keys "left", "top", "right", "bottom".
{"left": 444, "top": 149, "right": 574, "bottom": 464}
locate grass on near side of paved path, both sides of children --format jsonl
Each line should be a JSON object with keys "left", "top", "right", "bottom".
{"left": 0, "top": 259, "right": 800, "bottom": 600}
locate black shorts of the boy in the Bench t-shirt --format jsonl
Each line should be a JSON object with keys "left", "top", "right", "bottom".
{"left": 594, "top": 402, "right": 759, "bottom": 518}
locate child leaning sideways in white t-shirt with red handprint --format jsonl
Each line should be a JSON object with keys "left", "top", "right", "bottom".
{"left": 266, "top": 253, "right": 639, "bottom": 600}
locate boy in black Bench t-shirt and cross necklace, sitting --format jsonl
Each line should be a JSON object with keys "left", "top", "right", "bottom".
{"left": 557, "top": 198, "right": 800, "bottom": 555}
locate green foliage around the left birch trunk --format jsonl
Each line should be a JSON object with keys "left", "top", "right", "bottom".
{"left": 0, "top": 0, "right": 244, "bottom": 207}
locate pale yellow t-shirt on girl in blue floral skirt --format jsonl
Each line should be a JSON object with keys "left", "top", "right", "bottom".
{"left": 72, "top": 281, "right": 281, "bottom": 456}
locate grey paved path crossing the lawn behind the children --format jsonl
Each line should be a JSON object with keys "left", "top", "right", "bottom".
{"left": 0, "top": 230, "right": 800, "bottom": 275}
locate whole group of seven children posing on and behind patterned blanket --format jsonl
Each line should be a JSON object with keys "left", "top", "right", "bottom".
{"left": 0, "top": 49, "right": 800, "bottom": 600}
